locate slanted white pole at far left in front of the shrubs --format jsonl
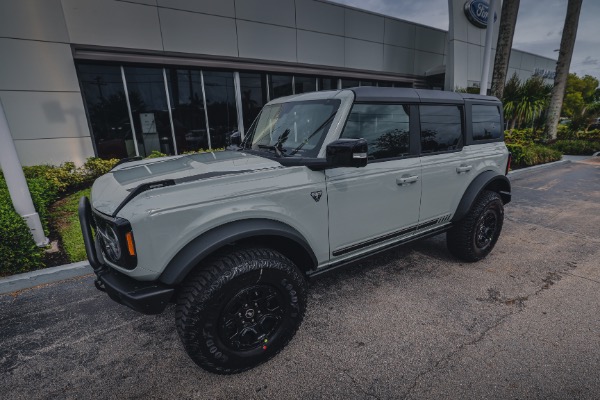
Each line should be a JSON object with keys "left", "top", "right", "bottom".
{"left": 0, "top": 97, "right": 49, "bottom": 247}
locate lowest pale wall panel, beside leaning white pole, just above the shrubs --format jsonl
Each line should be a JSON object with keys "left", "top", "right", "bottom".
{"left": 14, "top": 137, "right": 94, "bottom": 165}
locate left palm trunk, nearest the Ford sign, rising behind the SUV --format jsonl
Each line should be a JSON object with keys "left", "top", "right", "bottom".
{"left": 492, "top": 0, "right": 521, "bottom": 99}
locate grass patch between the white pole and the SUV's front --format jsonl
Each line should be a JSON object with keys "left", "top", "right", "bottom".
{"left": 50, "top": 188, "right": 90, "bottom": 262}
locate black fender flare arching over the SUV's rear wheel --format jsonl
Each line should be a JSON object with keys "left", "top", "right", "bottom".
{"left": 451, "top": 171, "right": 511, "bottom": 222}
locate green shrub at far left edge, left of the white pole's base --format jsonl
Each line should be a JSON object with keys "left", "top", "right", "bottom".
{"left": 0, "top": 176, "right": 42, "bottom": 276}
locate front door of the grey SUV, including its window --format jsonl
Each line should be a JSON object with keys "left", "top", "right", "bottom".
{"left": 326, "top": 103, "right": 421, "bottom": 259}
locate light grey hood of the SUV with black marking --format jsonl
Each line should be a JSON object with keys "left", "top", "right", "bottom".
{"left": 92, "top": 151, "right": 282, "bottom": 215}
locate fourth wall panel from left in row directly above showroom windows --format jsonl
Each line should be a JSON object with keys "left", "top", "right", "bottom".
{"left": 298, "top": 31, "right": 344, "bottom": 67}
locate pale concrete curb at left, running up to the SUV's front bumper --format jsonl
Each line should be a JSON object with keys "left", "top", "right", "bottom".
{"left": 0, "top": 261, "right": 94, "bottom": 294}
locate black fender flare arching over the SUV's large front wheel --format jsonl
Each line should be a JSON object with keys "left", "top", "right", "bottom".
{"left": 159, "top": 219, "right": 317, "bottom": 286}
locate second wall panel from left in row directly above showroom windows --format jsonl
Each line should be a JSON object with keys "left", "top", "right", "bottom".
{"left": 159, "top": 8, "right": 238, "bottom": 57}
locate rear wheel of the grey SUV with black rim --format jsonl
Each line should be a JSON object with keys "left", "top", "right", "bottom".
{"left": 446, "top": 190, "right": 504, "bottom": 262}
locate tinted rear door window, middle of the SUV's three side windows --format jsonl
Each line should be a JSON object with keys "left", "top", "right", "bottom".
{"left": 419, "top": 105, "right": 464, "bottom": 153}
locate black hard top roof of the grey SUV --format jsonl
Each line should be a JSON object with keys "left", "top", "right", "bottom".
{"left": 350, "top": 86, "right": 500, "bottom": 104}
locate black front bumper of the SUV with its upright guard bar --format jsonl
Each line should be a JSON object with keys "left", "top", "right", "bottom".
{"left": 79, "top": 196, "right": 175, "bottom": 314}
